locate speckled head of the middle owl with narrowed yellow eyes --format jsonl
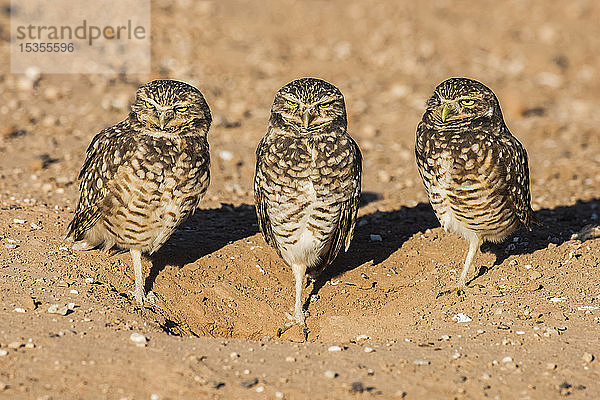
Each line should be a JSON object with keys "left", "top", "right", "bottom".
{"left": 271, "top": 78, "right": 346, "bottom": 136}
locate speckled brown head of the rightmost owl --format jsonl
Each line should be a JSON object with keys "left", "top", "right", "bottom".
{"left": 425, "top": 78, "right": 502, "bottom": 126}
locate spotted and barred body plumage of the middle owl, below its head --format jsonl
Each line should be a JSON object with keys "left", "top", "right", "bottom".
{"left": 255, "top": 128, "right": 362, "bottom": 267}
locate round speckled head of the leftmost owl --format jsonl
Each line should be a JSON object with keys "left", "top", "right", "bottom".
{"left": 130, "top": 80, "right": 212, "bottom": 135}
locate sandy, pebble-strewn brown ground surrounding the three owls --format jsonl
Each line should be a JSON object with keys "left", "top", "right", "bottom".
{"left": 0, "top": 0, "right": 600, "bottom": 399}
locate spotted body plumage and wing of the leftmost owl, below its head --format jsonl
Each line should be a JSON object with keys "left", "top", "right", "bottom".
{"left": 67, "top": 120, "right": 210, "bottom": 250}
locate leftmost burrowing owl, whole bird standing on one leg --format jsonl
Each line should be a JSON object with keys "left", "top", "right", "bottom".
{"left": 67, "top": 80, "right": 212, "bottom": 304}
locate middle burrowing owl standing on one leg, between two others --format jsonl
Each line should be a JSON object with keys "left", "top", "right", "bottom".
{"left": 254, "top": 78, "right": 362, "bottom": 335}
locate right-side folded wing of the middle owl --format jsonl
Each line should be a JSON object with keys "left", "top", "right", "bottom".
{"left": 324, "top": 136, "right": 362, "bottom": 265}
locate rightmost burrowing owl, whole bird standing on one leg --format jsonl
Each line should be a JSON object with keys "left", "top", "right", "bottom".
{"left": 415, "top": 78, "right": 537, "bottom": 294}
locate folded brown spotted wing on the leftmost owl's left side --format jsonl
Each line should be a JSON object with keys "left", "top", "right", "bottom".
{"left": 65, "top": 121, "right": 132, "bottom": 241}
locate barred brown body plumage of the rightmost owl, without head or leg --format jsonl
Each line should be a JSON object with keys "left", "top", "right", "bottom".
{"left": 415, "top": 122, "right": 538, "bottom": 231}
